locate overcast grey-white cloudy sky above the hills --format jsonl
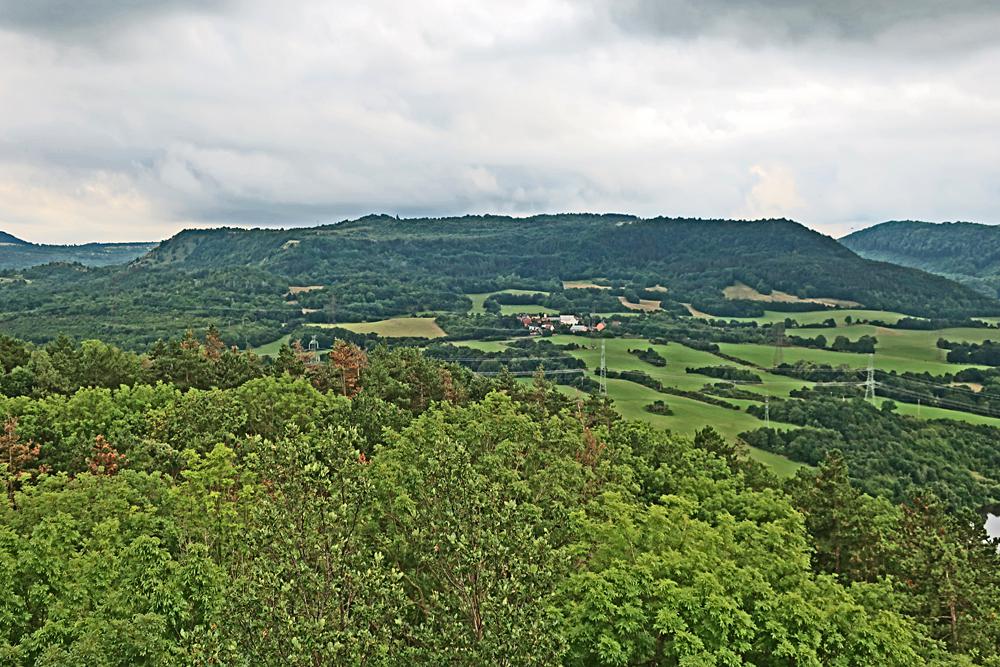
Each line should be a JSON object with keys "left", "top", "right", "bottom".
{"left": 0, "top": 0, "right": 1000, "bottom": 242}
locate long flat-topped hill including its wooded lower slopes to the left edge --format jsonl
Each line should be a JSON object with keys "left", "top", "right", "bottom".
{"left": 0, "top": 214, "right": 1000, "bottom": 346}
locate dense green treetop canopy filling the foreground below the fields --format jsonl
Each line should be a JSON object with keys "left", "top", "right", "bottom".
{"left": 0, "top": 330, "right": 1000, "bottom": 666}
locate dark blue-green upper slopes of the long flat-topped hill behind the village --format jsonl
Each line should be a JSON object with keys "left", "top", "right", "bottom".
{"left": 139, "top": 215, "right": 998, "bottom": 315}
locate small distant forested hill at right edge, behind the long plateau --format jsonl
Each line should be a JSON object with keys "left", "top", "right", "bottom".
{"left": 841, "top": 221, "right": 1000, "bottom": 297}
